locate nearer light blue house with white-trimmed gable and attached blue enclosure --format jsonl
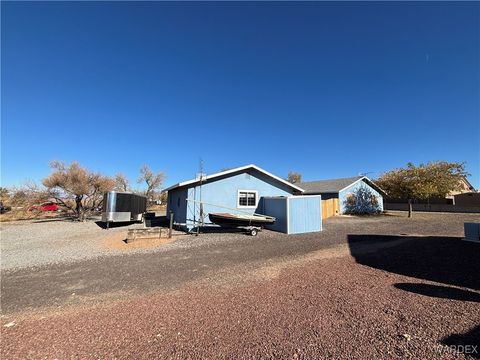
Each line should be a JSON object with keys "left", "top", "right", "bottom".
{"left": 164, "top": 164, "right": 321, "bottom": 233}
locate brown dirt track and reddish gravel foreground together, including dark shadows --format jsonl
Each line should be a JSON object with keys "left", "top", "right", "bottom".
{"left": 0, "top": 213, "right": 480, "bottom": 359}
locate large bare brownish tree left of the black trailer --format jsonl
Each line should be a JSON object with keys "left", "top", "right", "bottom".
{"left": 42, "top": 161, "right": 115, "bottom": 221}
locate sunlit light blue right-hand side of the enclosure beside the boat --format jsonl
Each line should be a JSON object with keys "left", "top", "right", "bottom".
{"left": 288, "top": 195, "right": 322, "bottom": 234}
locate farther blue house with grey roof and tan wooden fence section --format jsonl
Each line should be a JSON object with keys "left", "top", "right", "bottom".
{"left": 299, "top": 176, "right": 385, "bottom": 219}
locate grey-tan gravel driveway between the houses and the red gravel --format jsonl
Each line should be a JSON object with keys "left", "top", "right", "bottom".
{"left": 1, "top": 213, "right": 478, "bottom": 313}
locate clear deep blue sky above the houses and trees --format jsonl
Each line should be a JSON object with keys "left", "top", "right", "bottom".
{"left": 1, "top": 2, "right": 480, "bottom": 187}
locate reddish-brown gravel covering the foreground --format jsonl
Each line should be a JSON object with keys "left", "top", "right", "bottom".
{"left": 1, "top": 240, "right": 480, "bottom": 359}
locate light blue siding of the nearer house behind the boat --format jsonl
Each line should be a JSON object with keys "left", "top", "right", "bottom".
{"left": 168, "top": 170, "right": 294, "bottom": 230}
